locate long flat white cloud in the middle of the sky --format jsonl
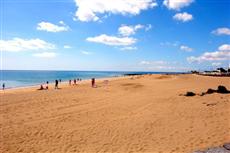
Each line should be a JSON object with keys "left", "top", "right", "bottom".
{"left": 86, "top": 34, "right": 137, "bottom": 46}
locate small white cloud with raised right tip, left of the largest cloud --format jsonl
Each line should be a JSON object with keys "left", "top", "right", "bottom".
{"left": 37, "top": 21, "right": 69, "bottom": 32}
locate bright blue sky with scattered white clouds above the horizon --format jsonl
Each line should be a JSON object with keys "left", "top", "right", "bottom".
{"left": 0, "top": 0, "right": 230, "bottom": 71}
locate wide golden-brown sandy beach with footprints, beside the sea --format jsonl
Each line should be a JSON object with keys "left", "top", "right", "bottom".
{"left": 0, "top": 75, "right": 230, "bottom": 153}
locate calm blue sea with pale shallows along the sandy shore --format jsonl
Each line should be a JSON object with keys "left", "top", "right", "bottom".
{"left": 0, "top": 70, "right": 179, "bottom": 89}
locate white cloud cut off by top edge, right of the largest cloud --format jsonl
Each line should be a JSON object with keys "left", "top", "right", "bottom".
{"left": 163, "top": 0, "right": 194, "bottom": 10}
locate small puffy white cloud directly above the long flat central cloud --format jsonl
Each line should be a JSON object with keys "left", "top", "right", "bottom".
{"left": 118, "top": 24, "right": 145, "bottom": 36}
